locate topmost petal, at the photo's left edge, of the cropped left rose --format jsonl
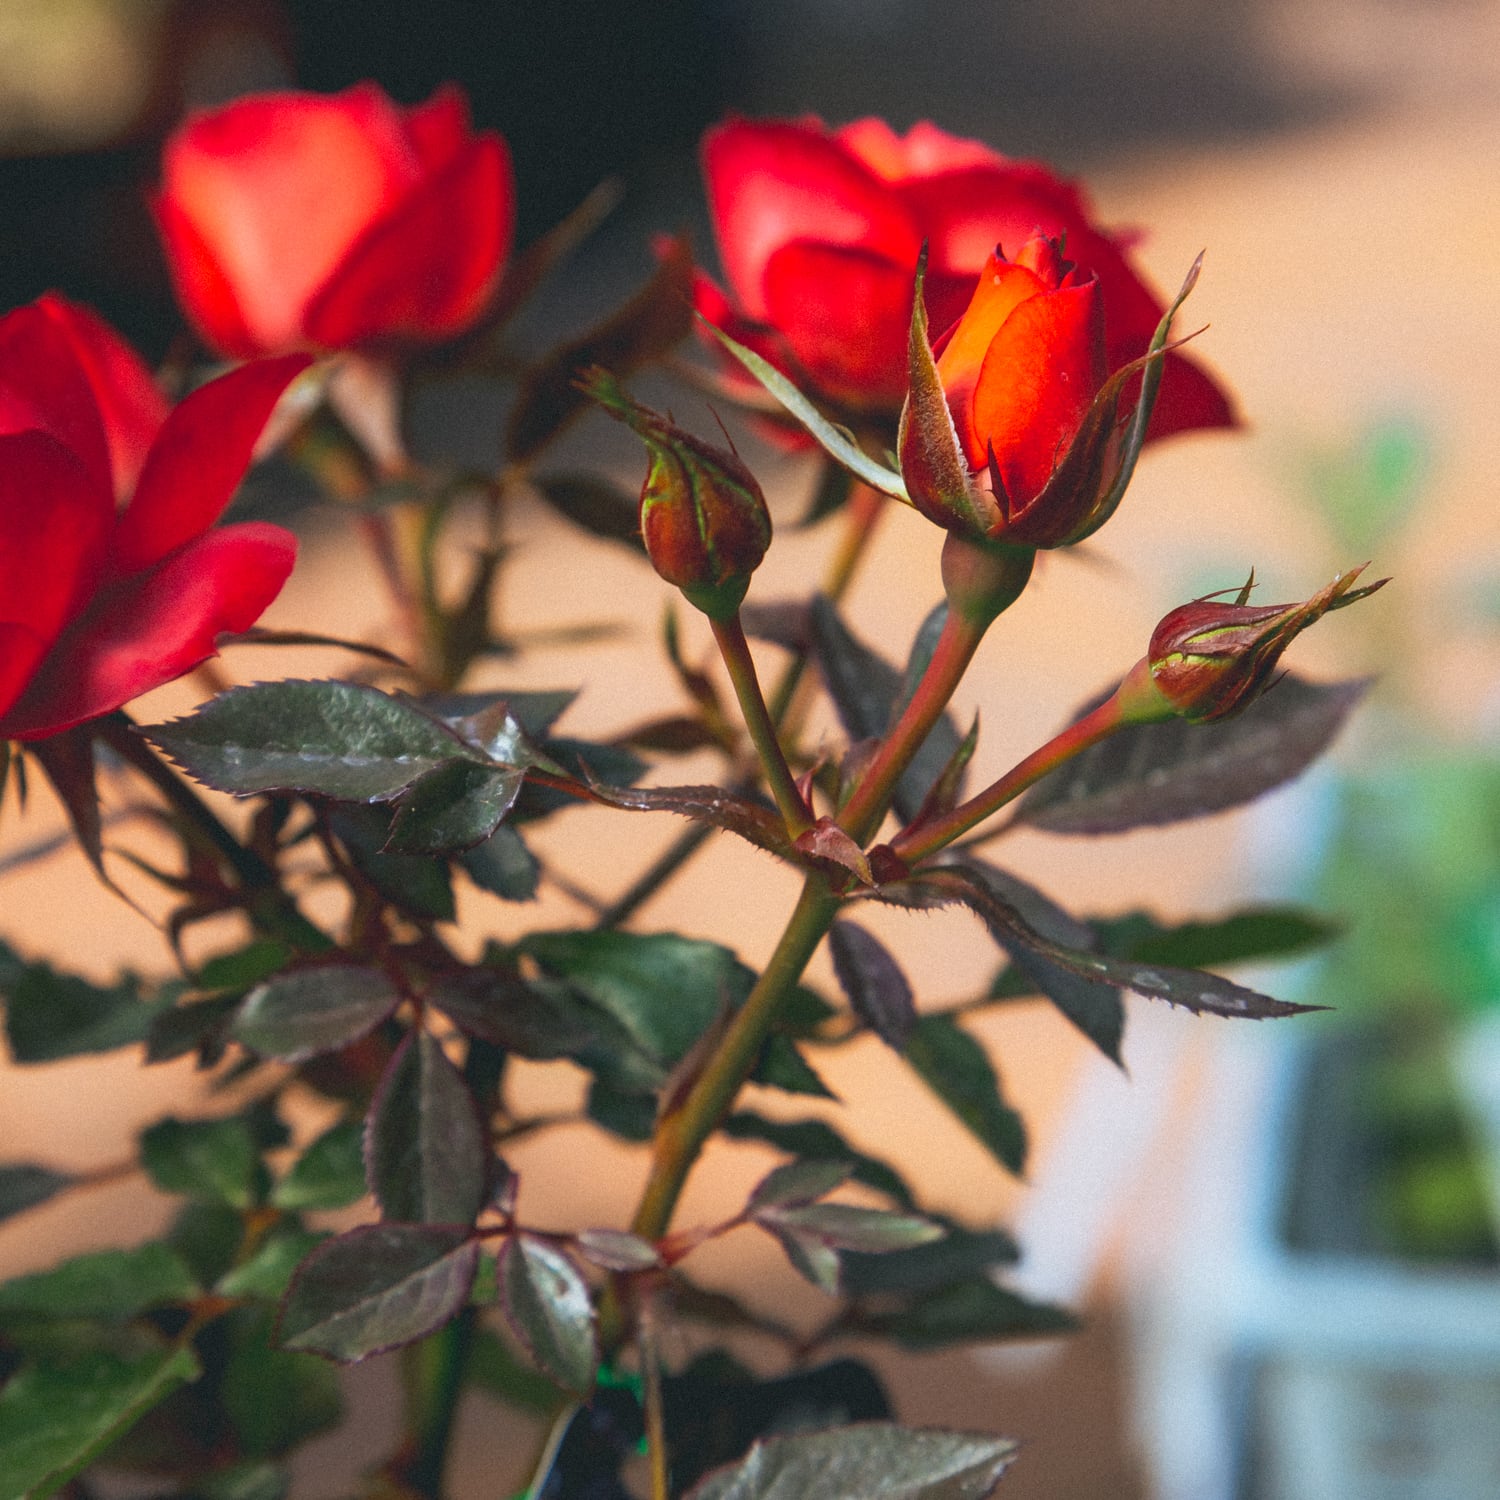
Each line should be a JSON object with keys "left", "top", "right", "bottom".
{"left": 0, "top": 303, "right": 114, "bottom": 494}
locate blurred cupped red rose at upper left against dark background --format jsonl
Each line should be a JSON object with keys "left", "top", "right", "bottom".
{"left": 156, "top": 84, "right": 515, "bottom": 359}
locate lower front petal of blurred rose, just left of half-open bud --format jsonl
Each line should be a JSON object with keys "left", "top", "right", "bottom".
{"left": 765, "top": 240, "right": 917, "bottom": 410}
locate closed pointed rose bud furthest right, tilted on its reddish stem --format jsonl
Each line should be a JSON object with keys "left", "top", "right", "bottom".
{"left": 1142, "top": 564, "right": 1389, "bottom": 723}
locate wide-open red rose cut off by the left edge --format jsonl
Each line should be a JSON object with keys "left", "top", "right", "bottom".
{"left": 0, "top": 296, "right": 308, "bottom": 740}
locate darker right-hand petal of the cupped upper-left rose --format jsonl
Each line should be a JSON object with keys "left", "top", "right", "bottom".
{"left": 306, "top": 132, "right": 515, "bottom": 348}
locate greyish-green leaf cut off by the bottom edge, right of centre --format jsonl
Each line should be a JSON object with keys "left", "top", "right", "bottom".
{"left": 687, "top": 1422, "right": 1016, "bottom": 1500}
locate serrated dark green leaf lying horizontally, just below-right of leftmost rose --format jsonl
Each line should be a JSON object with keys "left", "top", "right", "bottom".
{"left": 144, "top": 681, "right": 479, "bottom": 803}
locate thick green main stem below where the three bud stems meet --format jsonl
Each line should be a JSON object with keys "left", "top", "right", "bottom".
{"left": 630, "top": 873, "right": 839, "bottom": 1241}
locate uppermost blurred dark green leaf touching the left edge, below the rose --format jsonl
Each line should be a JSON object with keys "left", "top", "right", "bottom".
{"left": 0, "top": 942, "right": 171, "bottom": 1062}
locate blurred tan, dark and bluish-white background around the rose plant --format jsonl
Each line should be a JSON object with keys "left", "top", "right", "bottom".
{"left": 0, "top": 0, "right": 1500, "bottom": 1500}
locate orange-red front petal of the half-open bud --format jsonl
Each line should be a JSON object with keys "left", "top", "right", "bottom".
{"left": 966, "top": 282, "right": 1104, "bottom": 509}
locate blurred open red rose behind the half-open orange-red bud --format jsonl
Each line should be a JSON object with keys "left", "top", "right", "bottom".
{"left": 699, "top": 119, "right": 1235, "bottom": 438}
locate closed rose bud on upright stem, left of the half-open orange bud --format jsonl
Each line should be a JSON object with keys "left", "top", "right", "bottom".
{"left": 581, "top": 369, "right": 771, "bottom": 620}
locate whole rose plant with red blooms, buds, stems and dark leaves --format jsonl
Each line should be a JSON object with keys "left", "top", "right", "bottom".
{"left": 0, "top": 86, "right": 1379, "bottom": 1500}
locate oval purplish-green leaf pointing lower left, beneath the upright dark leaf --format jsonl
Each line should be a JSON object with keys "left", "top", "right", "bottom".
{"left": 278, "top": 1224, "right": 479, "bottom": 1364}
